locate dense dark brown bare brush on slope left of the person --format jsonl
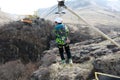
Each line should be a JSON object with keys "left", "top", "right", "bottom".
{"left": 0, "top": 20, "right": 53, "bottom": 63}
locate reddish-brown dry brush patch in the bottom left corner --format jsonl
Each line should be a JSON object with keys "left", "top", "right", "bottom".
{"left": 0, "top": 60, "right": 37, "bottom": 80}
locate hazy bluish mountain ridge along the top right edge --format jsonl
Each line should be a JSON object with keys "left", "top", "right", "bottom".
{"left": 66, "top": 0, "right": 120, "bottom": 12}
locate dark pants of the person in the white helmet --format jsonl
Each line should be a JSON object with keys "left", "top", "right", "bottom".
{"left": 58, "top": 44, "right": 71, "bottom": 60}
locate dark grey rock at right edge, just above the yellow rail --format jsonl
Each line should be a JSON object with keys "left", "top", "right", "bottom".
{"left": 94, "top": 52, "right": 120, "bottom": 76}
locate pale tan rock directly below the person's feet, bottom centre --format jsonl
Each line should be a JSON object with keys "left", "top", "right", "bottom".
{"left": 32, "top": 63, "right": 92, "bottom": 80}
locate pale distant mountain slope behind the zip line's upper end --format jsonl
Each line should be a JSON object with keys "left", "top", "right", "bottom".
{"left": 39, "top": 0, "right": 120, "bottom": 25}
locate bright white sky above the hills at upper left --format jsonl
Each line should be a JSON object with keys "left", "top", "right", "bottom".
{"left": 0, "top": 0, "right": 57, "bottom": 15}
